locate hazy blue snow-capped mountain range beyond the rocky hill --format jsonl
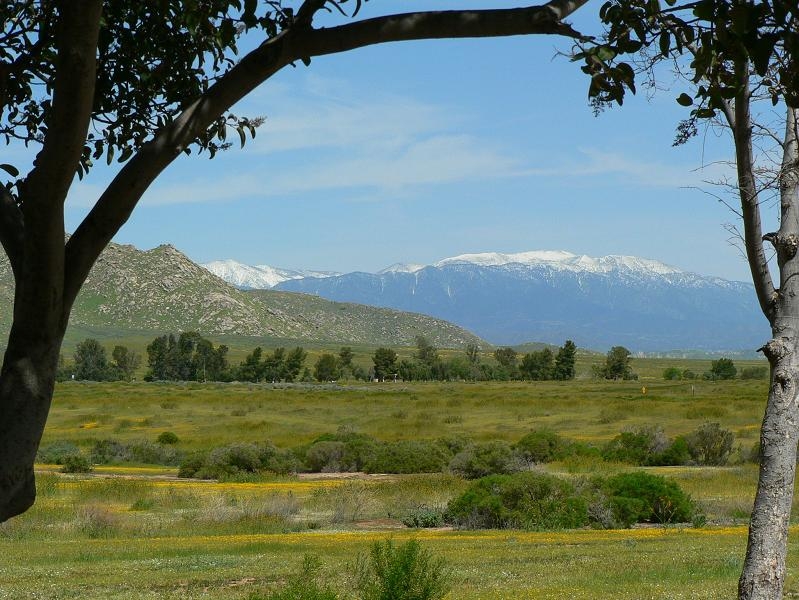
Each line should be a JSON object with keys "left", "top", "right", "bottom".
{"left": 205, "top": 251, "right": 769, "bottom": 352}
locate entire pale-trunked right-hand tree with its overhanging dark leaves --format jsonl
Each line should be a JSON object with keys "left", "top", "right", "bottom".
{"left": 575, "top": 0, "right": 799, "bottom": 600}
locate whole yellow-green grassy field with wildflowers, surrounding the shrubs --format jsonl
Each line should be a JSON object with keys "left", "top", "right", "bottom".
{"left": 0, "top": 378, "right": 799, "bottom": 599}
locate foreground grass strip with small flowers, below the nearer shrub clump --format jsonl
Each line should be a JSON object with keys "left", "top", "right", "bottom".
{"left": 0, "top": 527, "right": 788, "bottom": 599}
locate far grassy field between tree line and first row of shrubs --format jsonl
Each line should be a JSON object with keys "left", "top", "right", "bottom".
{"left": 44, "top": 380, "right": 767, "bottom": 449}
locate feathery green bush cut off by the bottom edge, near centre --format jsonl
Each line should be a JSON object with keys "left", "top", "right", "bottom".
{"left": 355, "top": 540, "right": 451, "bottom": 600}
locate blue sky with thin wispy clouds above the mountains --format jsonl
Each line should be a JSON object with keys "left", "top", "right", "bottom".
{"left": 53, "top": 0, "right": 780, "bottom": 281}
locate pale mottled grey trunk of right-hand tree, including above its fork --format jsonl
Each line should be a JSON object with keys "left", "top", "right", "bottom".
{"left": 736, "top": 107, "right": 799, "bottom": 600}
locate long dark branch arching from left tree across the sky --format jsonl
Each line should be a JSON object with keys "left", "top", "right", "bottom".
{"left": 64, "top": 0, "right": 588, "bottom": 314}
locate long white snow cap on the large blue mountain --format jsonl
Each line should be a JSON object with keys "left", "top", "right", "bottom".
{"left": 434, "top": 250, "right": 681, "bottom": 275}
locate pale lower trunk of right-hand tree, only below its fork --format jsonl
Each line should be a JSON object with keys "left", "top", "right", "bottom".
{"left": 738, "top": 332, "right": 799, "bottom": 600}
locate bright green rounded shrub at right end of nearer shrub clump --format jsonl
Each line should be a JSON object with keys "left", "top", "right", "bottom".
{"left": 600, "top": 471, "right": 695, "bottom": 526}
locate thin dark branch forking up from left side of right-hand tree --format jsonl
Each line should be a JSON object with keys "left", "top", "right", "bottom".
{"left": 732, "top": 61, "right": 776, "bottom": 322}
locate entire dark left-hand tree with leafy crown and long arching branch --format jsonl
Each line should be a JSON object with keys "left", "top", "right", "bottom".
{"left": 0, "top": 0, "right": 587, "bottom": 520}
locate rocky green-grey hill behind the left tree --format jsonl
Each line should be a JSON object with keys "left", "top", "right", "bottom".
{"left": 0, "top": 244, "right": 482, "bottom": 348}
